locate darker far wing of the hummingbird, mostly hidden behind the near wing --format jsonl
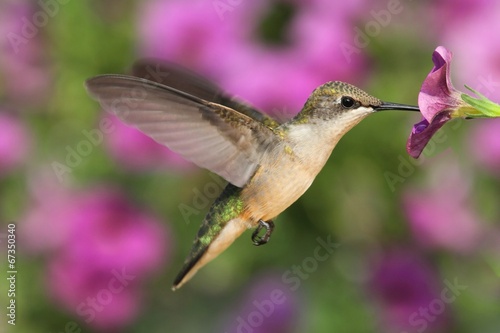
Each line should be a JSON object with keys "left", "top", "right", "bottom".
{"left": 132, "top": 59, "right": 288, "bottom": 128}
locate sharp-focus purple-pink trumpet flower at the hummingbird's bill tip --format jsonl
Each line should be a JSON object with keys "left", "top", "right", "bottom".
{"left": 406, "top": 46, "right": 476, "bottom": 158}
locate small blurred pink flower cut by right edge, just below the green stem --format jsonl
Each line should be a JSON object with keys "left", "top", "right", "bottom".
{"left": 468, "top": 119, "right": 500, "bottom": 176}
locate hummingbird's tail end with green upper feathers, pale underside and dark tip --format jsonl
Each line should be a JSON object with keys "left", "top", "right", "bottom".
{"left": 172, "top": 184, "right": 248, "bottom": 290}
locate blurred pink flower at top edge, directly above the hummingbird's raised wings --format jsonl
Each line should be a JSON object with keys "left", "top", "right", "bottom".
{"left": 139, "top": 0, "right": 230, "bottom": 75}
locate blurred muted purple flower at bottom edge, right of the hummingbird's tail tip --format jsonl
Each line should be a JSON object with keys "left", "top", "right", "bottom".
{"left": 223, "top": 275, "right": 300, "bottom": 333}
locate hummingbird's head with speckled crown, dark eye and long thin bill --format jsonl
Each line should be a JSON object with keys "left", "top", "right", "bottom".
{"left": 298, "top": 81, "right": 419, "bottom": 124}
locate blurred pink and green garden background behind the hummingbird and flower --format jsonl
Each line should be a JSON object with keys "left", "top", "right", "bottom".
{"left": 0, "top": 0, "right": 500, "bottom": 333}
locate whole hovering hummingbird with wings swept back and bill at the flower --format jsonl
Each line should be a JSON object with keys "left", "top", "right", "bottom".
{"left": 86, "top": 60, "right": 419, "bottom": 290}
